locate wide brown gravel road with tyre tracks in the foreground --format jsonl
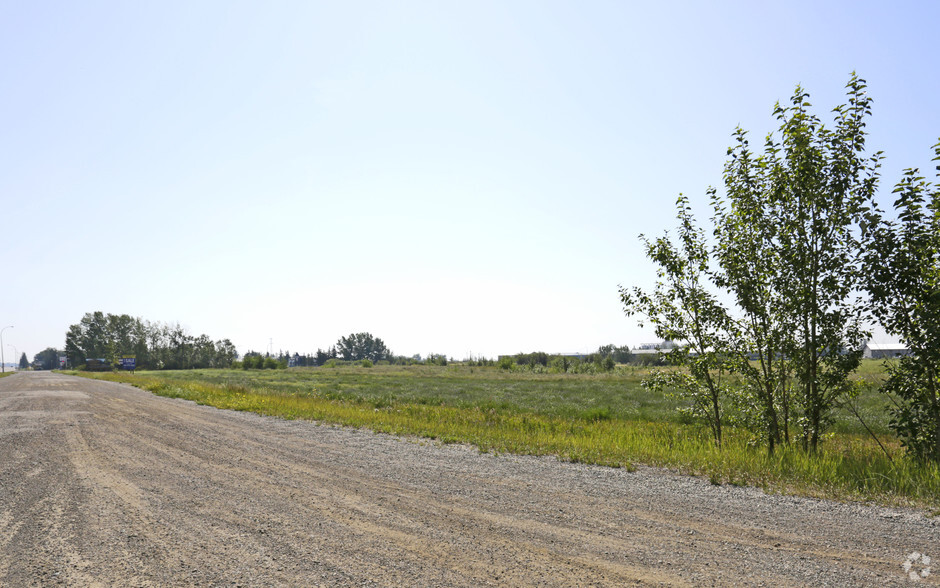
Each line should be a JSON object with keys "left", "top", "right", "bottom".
{"left": 0, "top": 372, "right": 940, "bottom": 586}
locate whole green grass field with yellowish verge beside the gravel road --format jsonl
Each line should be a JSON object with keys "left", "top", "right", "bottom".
{"left": 73, "top": 363, "right": 940, "bottom": 509}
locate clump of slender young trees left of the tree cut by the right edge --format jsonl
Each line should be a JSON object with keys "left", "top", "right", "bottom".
{"left": 621, "top": 74, "right": 881, "bottom": 451}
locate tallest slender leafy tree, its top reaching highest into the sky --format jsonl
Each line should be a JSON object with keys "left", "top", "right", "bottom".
{"left": 764, "top": 74, "right": 881, "bottom": 449}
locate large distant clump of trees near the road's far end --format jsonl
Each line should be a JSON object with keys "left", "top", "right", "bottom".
{"left": 65, "top": 312, "right": 238, "bottom": 369}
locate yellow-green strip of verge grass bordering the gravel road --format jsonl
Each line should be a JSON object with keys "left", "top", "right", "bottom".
{"left": 71, "top": 368, "right": 940, "bottom": 510}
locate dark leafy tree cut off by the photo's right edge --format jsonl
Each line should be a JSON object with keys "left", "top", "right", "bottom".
{"left": 865, "top": 143, "right": 940, "bottom": 462}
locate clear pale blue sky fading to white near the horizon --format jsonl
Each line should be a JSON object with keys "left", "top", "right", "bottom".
{"left": 0, "top": 0, "right": 940, "bottom": 360}
